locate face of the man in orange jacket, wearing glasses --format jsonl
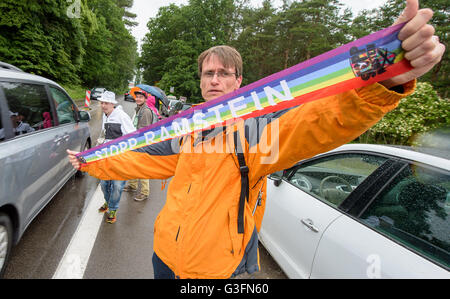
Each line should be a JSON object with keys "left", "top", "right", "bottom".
{"left": 200, "top": 55, "right": 242, "bottom": 101}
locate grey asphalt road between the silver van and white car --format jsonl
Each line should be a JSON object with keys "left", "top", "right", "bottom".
{"left": 1, "top": 97, "right": 286, "bottom": 279}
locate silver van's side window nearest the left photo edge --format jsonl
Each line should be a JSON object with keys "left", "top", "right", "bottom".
{"left": 0, "top": 82, "right": 54, "bottom": 136}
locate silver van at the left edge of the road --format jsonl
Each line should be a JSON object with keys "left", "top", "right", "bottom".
{"left": 0, "top": 62, "right": 91, "bottom": 277}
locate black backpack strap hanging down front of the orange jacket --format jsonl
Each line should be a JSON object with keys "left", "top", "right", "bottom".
{"left": 234, "top": 131, "right": 250, "bottom": 234}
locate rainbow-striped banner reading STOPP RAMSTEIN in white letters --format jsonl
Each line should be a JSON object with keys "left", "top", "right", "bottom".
{"left": 77, "top": 24, "right": 412, "bottom": 164}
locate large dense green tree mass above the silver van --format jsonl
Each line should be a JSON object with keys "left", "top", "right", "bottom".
{"left": 0, "top": 0, "right": 137, "bottom": 91}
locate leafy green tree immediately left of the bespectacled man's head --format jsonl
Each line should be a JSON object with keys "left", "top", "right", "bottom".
{"left": 140, "top": 0, "right": 239, "bottom": 102}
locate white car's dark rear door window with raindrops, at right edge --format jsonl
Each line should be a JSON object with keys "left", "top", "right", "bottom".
{"left": 360, "top": 164, "right": 450, "bottom": 268}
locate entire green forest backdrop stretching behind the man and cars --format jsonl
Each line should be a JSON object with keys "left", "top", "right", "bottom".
{"left": 0, "top": 0, "right": 450, "bottom": 144}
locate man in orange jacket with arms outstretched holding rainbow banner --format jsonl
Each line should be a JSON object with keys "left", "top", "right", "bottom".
{"left": 68, "top": 0, "right": 445, "bottom": 278}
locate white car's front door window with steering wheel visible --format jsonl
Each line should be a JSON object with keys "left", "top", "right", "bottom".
{"left": 285, "top": 154, "right": 387, "bottom": 207}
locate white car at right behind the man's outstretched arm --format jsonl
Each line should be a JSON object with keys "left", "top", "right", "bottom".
{"left": 259, "top": 144, "right": 450, "bottom": 279}
